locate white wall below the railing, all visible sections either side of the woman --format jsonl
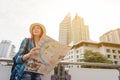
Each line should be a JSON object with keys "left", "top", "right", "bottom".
{"left": 0, "top": 65, "right": 119, "bottom": 80}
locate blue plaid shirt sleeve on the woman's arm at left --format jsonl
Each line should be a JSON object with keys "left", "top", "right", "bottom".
{"left": 13, "top": 38, "right": 28, "bottom": 64}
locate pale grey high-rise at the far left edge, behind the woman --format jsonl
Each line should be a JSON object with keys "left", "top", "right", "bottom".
{"left": 0, "top": 40, "right": 15, "bottom": 58}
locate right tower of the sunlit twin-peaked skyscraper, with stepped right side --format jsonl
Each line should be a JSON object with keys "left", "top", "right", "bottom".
{"left": 71, "top": 14, "right": 90, "bottom": 43}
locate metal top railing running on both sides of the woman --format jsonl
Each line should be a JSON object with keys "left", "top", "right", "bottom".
{"left": 0, "top": 59, "right": 120, "bottom": 80}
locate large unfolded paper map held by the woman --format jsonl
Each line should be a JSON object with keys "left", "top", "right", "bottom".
{"left": 26, "top": 36, "right": 71, "bottom": 74}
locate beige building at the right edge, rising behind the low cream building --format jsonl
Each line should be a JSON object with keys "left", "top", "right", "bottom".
{"left": 99, "top": 28, "right": 120, "bottom": 44}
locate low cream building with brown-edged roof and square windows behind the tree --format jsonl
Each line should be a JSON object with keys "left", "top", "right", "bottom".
{"left": 64, "top": 41, "right": 120, "bottom": 68}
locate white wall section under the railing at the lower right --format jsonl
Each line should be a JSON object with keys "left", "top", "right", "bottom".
{"left": 69, "top": 68, "right": 119, "bottom": 80}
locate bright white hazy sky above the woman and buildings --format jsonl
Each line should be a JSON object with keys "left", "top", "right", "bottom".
{"left": 0, "top": 0, "right": 120, "bottom": 50}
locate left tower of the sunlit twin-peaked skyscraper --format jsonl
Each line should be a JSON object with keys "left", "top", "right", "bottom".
{"left": 59, "top": 14, "right": 71, "bottom": 44}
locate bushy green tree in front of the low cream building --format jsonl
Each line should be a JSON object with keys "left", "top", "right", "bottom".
{"left": 82, "top": 50, "right": 113, "bottom": 68}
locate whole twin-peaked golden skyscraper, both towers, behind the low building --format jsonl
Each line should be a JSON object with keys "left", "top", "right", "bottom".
{"left": 59, "top": 14, "right": 90, "bottom": 45}
